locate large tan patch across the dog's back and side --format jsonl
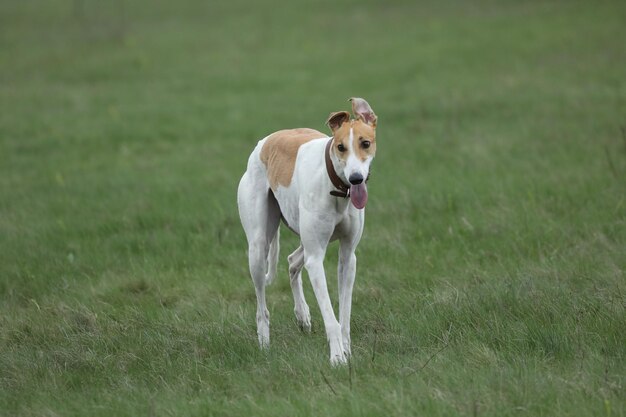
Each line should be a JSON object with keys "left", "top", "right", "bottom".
{"left": 261, "top": 128, "right": 326, "bottom": 191}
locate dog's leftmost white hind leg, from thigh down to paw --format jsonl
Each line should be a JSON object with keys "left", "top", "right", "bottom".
{"left": 237, "top": 172, "right": 280, "bottom": 348}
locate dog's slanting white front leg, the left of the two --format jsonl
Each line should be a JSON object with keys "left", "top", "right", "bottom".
{"left": 300, "top": 211, "right": 346, "bottom": 365}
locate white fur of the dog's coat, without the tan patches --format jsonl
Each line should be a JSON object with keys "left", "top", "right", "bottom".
{"left": 237, "top": 132, "right": 371, "bottom": 364}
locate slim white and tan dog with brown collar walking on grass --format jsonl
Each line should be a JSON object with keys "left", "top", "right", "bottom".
{"left": 237, "top": 98, "right": 378, "bottom": 365}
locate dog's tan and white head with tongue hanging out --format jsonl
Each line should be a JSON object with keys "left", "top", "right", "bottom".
{"left": 326, "top": 98, "right": 378, "bottom": 209}
